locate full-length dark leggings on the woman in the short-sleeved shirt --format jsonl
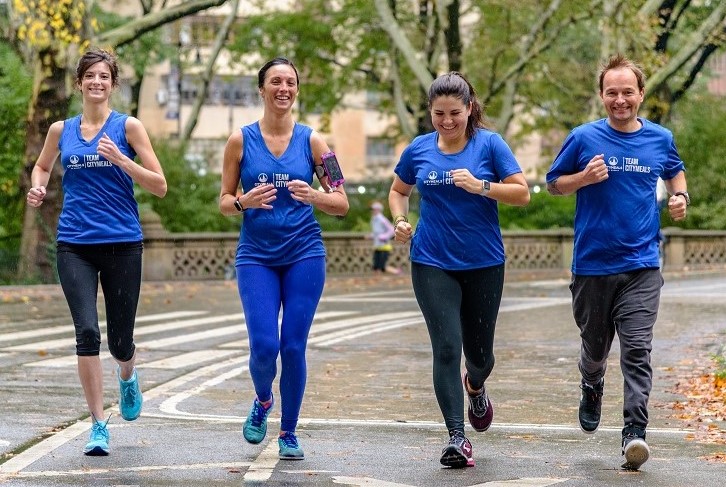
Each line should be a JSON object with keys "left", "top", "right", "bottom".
{"left": 411, "top": 262, "right": 504, "bottom": 431}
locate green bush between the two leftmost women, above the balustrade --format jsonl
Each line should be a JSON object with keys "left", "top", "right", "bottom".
{"left": 137, "top": 141, "right": 240, "bottom": 232}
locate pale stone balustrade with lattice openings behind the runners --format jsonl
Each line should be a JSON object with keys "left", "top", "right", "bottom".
{"left": 143, "top": 214, "right": 726, "bottom": 281}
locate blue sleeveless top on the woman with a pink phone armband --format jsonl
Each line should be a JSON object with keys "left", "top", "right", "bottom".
{"left": 235, "top": 122, "right": 325, "bottom": 265}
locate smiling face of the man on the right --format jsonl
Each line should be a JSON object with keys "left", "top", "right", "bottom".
{"left": 600, "top": 68, "right": 644, "bottom": 128}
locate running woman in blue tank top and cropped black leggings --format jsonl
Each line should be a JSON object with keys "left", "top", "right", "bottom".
{"left": 27, "top": 49, "right": 166, "bottom": 455}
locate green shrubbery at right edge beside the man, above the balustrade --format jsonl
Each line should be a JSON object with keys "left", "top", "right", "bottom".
{"left": 661, "top": 90, "right": 726, "bottom": 230}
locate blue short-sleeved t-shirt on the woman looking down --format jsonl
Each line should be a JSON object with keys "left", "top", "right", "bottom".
{"left": 395, "top": 129, "right": 522, "bottom": 270}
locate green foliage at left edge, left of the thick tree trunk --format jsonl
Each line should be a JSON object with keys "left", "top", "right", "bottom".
{"left": 0, "top": 41, "right": 32, "bottom": 283}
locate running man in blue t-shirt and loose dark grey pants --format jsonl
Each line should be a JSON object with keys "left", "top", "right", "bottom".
{"left": 547, "top": 55, "right": 690, "bottom": 470}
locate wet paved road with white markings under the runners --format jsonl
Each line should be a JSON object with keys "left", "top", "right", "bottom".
{"left": 0, "top": 275, "right": 726, "bottom": 487}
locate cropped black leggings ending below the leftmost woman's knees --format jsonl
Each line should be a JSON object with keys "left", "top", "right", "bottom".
{"left": 57, "top": 242, "right": 144, "bottom": 362}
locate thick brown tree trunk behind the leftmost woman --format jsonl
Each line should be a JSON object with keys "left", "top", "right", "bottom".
{"left": 18, "top": 52, "right": 69, "bottom": 283}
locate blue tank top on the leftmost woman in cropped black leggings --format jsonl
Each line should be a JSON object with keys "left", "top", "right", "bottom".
{"left": 57, "top": 111, "right": 143, "bottom": 244}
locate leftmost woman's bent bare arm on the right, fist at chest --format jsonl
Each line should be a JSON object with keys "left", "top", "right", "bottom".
{"left": 98, "top": 117, "right": 166, "bottom": 198}
